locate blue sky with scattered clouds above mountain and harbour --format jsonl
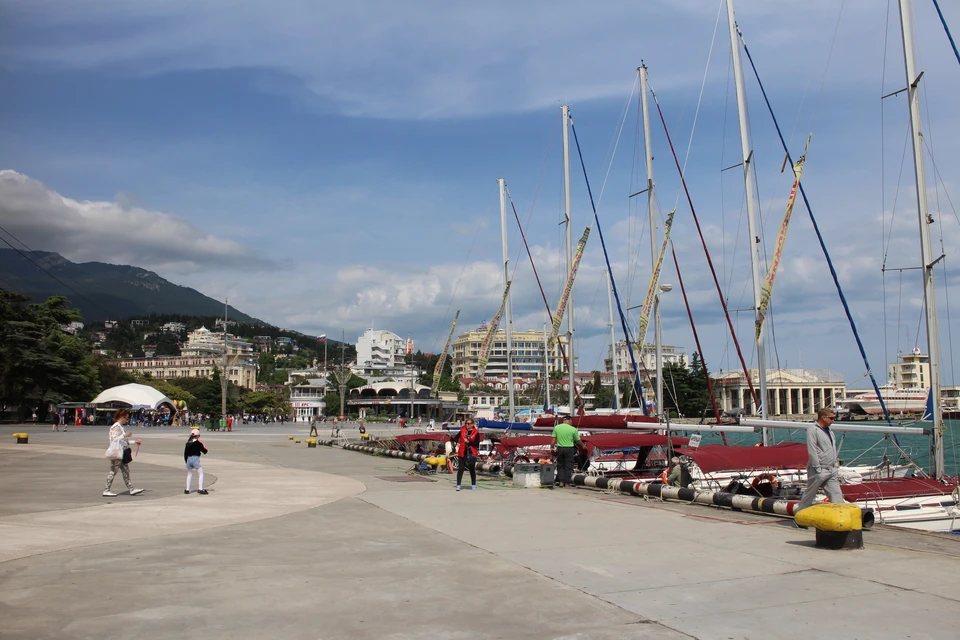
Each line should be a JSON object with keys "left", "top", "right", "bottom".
{"left": 0, "top": 0, "right": 960, "bottom": 388}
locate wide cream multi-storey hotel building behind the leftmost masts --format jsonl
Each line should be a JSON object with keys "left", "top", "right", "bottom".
{"left": 452, "top": 326, "right": 567, "bottom": 380}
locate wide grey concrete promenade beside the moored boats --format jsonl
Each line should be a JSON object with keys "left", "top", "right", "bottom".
{"left": 0, "top": 423, "right": 960, "bottom": 640}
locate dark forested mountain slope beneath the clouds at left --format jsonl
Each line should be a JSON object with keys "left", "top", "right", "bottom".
{"left": 0, "top": 249, "right": 266, "bottom": 324}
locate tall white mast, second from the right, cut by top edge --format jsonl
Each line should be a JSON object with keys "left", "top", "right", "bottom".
{"left": 727, "top": 0, "right": 770, "bottom": 445}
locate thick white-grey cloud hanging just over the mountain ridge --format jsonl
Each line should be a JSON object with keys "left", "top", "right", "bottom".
{"left": 0, "top": 169, "right": 271, "bottom": 274}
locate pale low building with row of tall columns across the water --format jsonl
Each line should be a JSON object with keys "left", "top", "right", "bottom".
{"left": 710, "top": 369, "right": 847, "bottom": 416}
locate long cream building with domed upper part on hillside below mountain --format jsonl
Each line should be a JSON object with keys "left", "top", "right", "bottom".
{"left": 118, "top": 327, "right": 257, "bottom": 389}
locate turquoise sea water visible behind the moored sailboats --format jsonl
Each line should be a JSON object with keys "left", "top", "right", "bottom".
{"left": 689, "top": 420, "right": 960, "bottom": 476}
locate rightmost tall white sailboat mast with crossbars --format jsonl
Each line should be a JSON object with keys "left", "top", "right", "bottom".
{"left": 900, "top": 0, "right": 944, "bottom": 480}
